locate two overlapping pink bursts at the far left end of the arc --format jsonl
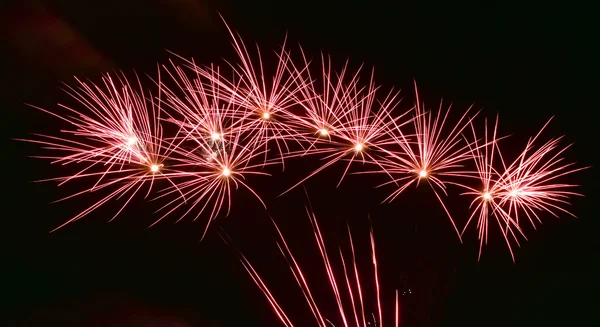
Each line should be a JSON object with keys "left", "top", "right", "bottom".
{"left": 18, "top": 74, "right": 185, "bottom": 230}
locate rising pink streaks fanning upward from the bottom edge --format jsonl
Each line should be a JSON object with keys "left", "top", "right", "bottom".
{"left": 224, "top": 204, "right": 400, "bottom": 327}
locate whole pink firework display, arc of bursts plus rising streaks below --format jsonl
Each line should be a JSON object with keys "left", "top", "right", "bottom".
{"left": 17, "top": 18, "right": 583, "bottom": 326}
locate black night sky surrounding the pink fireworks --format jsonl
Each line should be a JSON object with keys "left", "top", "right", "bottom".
{"left": 0, "top": 0, "right": 600, "bottom": 327}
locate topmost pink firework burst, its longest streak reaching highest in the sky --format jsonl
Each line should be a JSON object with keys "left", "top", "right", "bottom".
{"left": 170, "top": 18, "right": 307, "bottom": 167}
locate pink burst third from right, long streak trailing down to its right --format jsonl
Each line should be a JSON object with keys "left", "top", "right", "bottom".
{"left": 358, "top": 84, "right": 477, "bottom": 242}
